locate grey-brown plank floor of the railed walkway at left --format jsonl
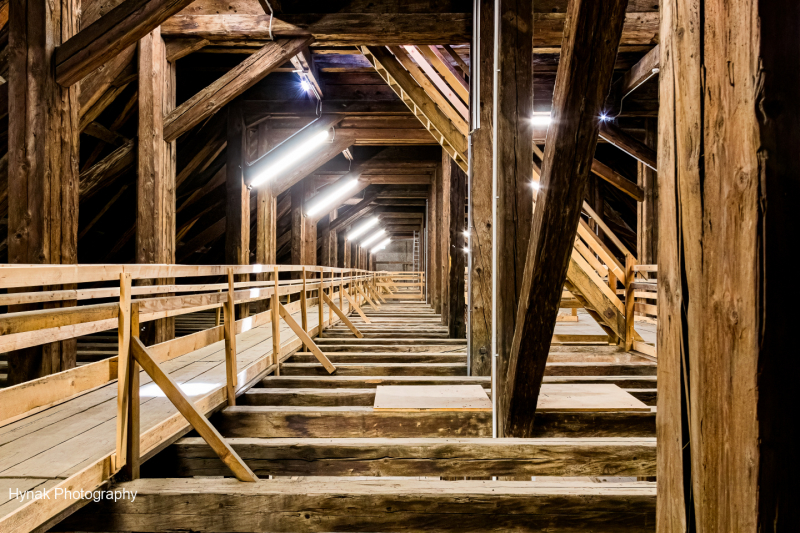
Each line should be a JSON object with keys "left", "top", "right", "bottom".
{"left": 0, "top": 303, "right": 349, "bottom": 533}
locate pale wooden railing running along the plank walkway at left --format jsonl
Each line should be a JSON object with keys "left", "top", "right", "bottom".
{"left": 0, "top": 265, "right": 377, "bottom": 428}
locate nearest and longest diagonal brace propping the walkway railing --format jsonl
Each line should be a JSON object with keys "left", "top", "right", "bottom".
{"left": 131, "top": 337, "right": 258, "bottom": 481}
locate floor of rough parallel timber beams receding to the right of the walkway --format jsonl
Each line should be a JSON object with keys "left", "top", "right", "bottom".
{"left": 59, "top": 302, "right": 656, "bottom": 532}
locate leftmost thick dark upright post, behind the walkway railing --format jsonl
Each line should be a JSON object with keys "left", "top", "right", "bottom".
{"left": 3, "top": 0, "right": 80, "bottom": 386}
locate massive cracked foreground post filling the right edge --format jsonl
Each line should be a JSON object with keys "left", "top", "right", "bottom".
{"left": 656, "top": 0, "right": 800, "bottom": 533}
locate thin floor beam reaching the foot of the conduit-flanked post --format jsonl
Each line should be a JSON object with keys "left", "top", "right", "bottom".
{"left": 281, "top": 363, "right": 467, "bottom": 376}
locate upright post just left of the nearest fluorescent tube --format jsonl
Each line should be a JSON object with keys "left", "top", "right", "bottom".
{"left": 225, "top": 102, "right": 250, "bottom": 318}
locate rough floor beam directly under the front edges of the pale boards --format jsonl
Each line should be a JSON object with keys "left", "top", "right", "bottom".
{"left": 214, "top": 405, "right": 656, "bottom": 438}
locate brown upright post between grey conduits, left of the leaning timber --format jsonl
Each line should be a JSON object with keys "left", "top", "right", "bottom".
{"left": 468, "top": 0, "right": 494, "bottom": 376}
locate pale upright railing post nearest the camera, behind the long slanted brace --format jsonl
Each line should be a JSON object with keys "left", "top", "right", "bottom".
{"left": 117, "top": 273, "right": 136, "bottom": 469}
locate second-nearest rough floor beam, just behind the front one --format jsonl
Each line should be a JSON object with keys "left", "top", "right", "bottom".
{"left": 155, "top": 437, "right": 656, "bottom": 477}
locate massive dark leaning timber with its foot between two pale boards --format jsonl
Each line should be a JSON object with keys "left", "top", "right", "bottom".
{"left": 499, "top": 0, "right": 628, "bottom": 437}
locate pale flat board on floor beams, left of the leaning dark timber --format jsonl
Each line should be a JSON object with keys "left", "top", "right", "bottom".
{"left": 374, "top": 385, "right": 492, "bottom": 411}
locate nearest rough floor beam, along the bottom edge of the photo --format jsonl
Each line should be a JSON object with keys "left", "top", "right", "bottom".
{"left": 59, "top": 477, "right": 656, "bottom": 533}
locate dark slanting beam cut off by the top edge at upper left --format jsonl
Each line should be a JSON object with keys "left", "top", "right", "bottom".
{"left": 54, "top": 0, "right": 198, "bottom": 87}
